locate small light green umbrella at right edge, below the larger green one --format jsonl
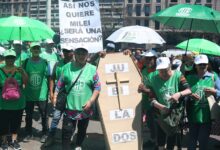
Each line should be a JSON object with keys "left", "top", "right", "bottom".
{"left": 176, "top": 38, "right": 220, "bottom": 56}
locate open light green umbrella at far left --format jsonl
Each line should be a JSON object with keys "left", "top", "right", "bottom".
{"left": 0, "top": 16, "right": 55, "bottom": 41}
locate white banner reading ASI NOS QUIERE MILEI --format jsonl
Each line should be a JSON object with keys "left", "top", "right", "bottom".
{"left": 59, "top": 0, "right": 103, "bottom": 53}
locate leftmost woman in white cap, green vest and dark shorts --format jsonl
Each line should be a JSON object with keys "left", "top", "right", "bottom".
{"left": 0, "top": 50, "right": 28, "bottom": 149}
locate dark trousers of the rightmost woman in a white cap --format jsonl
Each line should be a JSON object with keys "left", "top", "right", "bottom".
{"left": 188, "top": 123, "right": 211, "bottom": 150}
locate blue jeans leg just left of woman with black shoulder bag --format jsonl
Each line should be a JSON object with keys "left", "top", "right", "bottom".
{"left": 49, "top": 108, "right": 63, "bottom": 136}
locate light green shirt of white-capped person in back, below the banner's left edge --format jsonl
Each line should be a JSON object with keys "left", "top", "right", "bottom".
{"left": 40, "top": 51, "right": 60, "bottom": 75}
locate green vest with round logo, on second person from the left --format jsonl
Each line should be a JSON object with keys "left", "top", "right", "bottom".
{"left": 24, "top": 58, "right": 50, "bottom": 101}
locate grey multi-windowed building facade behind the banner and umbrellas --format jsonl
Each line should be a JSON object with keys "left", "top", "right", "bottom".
{"left": 0, "top": 0, "right": 220, "bottom": 34}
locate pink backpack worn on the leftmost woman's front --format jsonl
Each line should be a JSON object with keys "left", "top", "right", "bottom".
{"left": 2, "top": 70, "right": 21, "bottom": 101}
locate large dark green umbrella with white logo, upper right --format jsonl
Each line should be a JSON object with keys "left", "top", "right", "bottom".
{"left": 151, "top": 4, "right": 220, "bottom": 33}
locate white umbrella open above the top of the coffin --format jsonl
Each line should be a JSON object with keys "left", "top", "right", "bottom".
{"left": 106, "top": 26, "right": 165, "bottom": 44}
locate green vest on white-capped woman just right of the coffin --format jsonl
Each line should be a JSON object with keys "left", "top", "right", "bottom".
{"left": 149, "top": 70, "right": 182, "bottom": 108}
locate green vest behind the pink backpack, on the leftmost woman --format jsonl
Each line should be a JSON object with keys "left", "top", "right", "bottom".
{"left": 0, "top": 69, "right": 26, "bottom": 110}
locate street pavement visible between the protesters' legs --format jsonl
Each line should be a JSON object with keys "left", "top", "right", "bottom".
{"left": 13, "top": 106, "right": 220, "bottom": 150}
